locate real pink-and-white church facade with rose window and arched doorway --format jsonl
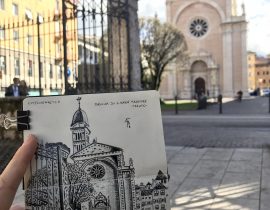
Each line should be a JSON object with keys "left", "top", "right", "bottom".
{"left": 160, "top": 0, "right": 248, "bottom": 99}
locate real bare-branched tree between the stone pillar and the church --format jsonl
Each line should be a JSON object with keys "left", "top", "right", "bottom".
{"left": 139, "top": 18, "right": 187, "bottom": 90}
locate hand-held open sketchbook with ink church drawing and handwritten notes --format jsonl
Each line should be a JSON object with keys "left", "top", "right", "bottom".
{"left": 23, "top": 91, "right": 169, "bottom": 210}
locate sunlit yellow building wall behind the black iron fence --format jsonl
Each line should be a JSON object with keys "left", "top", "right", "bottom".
{"left": 0, "top": 0, "right": 78, "bottom": 96}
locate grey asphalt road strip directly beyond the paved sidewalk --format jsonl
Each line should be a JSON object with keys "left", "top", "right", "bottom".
{"left": 163, "top": 115, "right": 270, "bottom": 148}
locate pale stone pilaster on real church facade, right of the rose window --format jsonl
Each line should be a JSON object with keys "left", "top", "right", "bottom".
{"left": 220, "top": 24, "right": 233, "bottom": 97}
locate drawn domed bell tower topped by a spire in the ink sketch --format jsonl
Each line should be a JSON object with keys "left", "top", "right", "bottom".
{"left": 70, "top": 97, "right": 91, "bottom": 154}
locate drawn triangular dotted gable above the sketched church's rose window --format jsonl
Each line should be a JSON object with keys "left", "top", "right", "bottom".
{"left": 71, "top": 140, "right": 123, "bottom": 158}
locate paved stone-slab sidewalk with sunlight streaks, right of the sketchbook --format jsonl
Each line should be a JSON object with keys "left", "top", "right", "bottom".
{"left": 166, "top": 147, "right": 270, "bottom": 210}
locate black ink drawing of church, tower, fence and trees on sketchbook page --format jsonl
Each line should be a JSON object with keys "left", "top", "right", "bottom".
{"left": 25, "top": 98, "right": 168, "bottom": 210}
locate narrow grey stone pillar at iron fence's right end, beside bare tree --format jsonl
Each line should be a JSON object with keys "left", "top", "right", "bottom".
{"left": 128, "top": 0, "right": 141, "bottom": 90}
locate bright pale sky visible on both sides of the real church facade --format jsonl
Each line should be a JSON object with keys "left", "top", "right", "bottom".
{"left": 139, "top": 0, "right": 270, "bottom": 55}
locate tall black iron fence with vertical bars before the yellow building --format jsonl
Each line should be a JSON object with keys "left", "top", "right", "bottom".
{"left": 0, "top": 0, "right": 130, "bottom": 96}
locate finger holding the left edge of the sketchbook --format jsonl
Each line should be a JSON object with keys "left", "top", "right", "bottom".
{"left": 0, "top": 135, "right": 37, "bottom": 209}
